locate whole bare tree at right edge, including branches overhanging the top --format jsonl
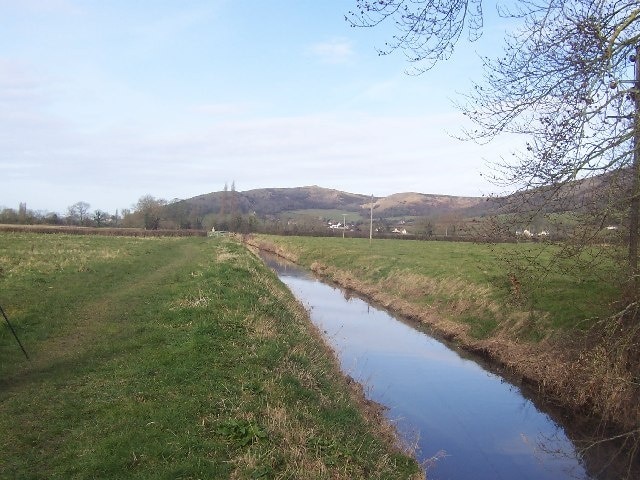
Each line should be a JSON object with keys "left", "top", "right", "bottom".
{"left": 347, "top": 0, "right": 640, "bottom": 474}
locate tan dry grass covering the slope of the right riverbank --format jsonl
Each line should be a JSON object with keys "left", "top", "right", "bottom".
{"left": 248, "top": 235, "right": 640, "bottom": 431}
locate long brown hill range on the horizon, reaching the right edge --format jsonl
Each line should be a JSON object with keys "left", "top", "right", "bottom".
{"left": 168, "top": 170, "right": 631, "bottom": 232}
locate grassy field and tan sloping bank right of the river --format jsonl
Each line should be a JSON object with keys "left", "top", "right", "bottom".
{"left": 250, "top": 236, "right": 640, "bottom": 436}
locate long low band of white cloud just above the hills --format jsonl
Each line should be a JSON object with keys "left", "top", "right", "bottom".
{"left": 0, "top": 106, "right": 516, "bottom": 211}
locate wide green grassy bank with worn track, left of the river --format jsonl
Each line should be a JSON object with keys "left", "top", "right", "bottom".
{"left": 0, "top": 233, "right": 418, "bottom": 479}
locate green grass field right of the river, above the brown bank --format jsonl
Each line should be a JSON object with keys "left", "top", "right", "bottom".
{"left": 252, "top": 236, "right": 619, "bottom": 340}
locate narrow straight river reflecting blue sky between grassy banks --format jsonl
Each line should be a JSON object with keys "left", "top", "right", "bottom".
{"left": 263, "top": 254, "right": 632, "bottom": 480}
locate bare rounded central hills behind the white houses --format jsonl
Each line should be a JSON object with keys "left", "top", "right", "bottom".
{"left": 182, "top": 185, "right": 491, "bottom": 217}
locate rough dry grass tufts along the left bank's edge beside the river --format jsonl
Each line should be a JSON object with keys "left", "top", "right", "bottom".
{"left": 218, "top": 246, "right": 424, "bottom": 480}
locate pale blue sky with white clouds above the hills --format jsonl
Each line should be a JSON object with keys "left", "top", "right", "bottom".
{"left": 0, "top": 0, "right": 515, "bottom": 213}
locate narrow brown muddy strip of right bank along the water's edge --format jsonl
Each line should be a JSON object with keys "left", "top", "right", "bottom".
{"left": 245, "top": 237, "right": 640, "bottom": 438}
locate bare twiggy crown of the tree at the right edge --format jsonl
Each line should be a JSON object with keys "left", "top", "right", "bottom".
{"left": 463, "top": 0, "right": 640, "bottom": 284}
